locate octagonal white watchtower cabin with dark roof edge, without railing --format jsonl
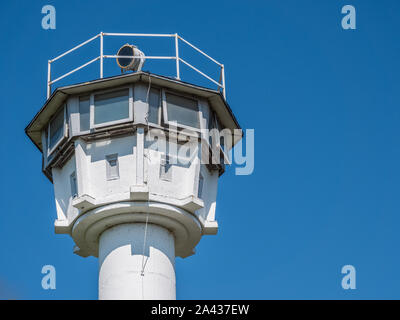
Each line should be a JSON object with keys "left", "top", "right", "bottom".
{"left": 26, "top": 72, "right": 242, "bottom": 256}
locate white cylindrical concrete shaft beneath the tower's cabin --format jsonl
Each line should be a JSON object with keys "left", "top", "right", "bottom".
{"left": 99, "top": 223, "right": 176, "bottom": 300}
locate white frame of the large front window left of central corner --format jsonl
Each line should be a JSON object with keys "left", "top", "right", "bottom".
{"left": 88, "top": 85, "right": 133, "bottom": 132}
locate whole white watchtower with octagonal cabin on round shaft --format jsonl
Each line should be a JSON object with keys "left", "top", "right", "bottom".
{"left": 26, "top": 33, "right": 242, "bottom": 299}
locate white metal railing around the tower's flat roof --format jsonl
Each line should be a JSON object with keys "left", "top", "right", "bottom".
{"left": 47, "top": 32, "right": 226, "bottom": 99}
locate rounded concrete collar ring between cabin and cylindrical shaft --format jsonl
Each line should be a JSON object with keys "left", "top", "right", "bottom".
{"left": 71, "top": 201, "right": 203, "bottom": 257}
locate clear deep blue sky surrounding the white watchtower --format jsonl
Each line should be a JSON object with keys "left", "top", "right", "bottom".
{"left": 0, "top": 0, "right": 400, "bottom": 299}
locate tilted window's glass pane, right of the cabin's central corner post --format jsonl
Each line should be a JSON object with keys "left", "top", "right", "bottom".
{"left": 166, "top": 93, "right": 199, "bottom": 128}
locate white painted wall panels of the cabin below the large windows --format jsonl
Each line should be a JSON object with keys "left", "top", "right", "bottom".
{"left": 53, "top": 135, "right": 218, "bottom": 232}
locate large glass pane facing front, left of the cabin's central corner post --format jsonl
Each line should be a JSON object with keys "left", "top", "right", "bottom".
{"left": 94, "top": 89, "right": 129, "bottom": 124}
